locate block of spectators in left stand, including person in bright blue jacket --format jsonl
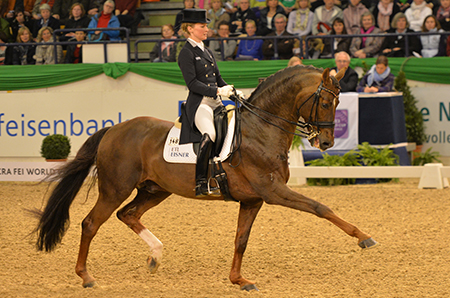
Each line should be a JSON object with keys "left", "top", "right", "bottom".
{"left": 0, "top": 0, "right": 142, "bottom": 65}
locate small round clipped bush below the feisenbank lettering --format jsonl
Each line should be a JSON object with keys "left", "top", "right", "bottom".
{"left": 41, "top": 134, "right": 70, "bottom": 161}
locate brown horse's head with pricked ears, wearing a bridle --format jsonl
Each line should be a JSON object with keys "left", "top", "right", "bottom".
{"left": 299, "top": 68, "right": 345, "bottom": 151}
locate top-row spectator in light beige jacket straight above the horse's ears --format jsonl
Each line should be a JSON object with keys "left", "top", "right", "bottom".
{"left": 312, "top": 0, "right": 344, "bottom": 35}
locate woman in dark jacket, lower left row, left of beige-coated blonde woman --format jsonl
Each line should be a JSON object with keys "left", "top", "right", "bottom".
{"left": 12, "top": 27, "right": 36, "bottom": 65}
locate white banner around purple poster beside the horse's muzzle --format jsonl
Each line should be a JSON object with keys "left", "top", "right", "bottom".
{"left": 303, "top": 92, "right": 359, "bottom": 150}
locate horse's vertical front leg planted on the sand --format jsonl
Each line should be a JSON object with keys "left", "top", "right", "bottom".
{"left": 230, "top": 200, "right": 263, "bottom": 291}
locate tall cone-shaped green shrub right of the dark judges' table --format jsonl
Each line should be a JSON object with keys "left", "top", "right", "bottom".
{"left": 394, "top": 71, "right": 427, "bottom": 148}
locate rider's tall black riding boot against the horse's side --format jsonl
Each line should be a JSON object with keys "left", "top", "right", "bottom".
{"left": 195, "top": 133, "right": 221, "bottom": 197}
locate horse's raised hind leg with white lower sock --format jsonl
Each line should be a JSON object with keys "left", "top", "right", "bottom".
{"left": 117, "top": 189, "right": 171, "bottom": 273}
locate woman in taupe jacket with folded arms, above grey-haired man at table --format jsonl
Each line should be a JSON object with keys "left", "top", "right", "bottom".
{"left": 350, "top": 11, "right": 383, "bottom": 58}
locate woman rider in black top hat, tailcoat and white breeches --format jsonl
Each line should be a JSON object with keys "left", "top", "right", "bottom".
{"left": 178, "top": 9, "right": 243, "bottom": 197}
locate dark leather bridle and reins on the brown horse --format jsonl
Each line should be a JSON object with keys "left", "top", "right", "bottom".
{"left": 230, "top": 81, "right": 340, "bottom": 140}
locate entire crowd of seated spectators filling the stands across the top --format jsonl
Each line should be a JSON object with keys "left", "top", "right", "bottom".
{"left": 0, "top": 0, "right": 450, "bottom": 90}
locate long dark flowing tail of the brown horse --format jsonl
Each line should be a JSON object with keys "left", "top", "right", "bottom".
{"left": 35, "top": 127, "right": 111, "bottom": 252}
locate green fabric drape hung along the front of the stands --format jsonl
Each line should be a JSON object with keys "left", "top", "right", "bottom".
{"left": 0, "top": 57, "right": 450, "bottom": 91}
